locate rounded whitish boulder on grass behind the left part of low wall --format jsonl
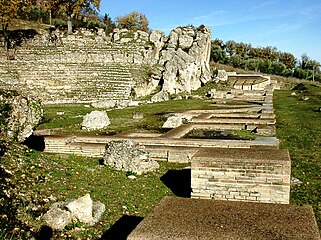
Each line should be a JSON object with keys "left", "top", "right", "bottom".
{"left": 81, "top": 111, "right": 110, "bottom": 131}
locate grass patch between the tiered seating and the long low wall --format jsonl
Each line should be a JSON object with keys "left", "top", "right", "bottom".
{"left": 38, "top": 99, "right": 220, "bottom": 134}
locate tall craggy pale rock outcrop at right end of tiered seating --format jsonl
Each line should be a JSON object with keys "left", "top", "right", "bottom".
{"left": 159, "top": 26, "right": 211, "bottom": 94}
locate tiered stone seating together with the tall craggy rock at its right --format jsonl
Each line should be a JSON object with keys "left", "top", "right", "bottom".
{"left": 0, "top": 26, "right": 211, "bottom": 104}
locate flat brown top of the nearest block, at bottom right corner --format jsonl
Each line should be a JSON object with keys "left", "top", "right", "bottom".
{"left": 127, "top": 197, "right": 320, "bottom": 240}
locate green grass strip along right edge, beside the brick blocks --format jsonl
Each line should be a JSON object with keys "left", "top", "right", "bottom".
{"left": 274, "top": 85, "right": 321, "bottom": 228}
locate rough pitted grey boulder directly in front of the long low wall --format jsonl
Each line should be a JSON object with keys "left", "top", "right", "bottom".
{"left": 103, "top": 140, "right": 159, "bottom": 175}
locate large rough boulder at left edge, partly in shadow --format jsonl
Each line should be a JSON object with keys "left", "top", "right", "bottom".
{"left": 0, "top": 90, "right": 43, "bottom": 142}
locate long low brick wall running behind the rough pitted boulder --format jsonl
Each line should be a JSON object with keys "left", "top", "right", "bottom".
{"left": 43, "top": 135, "right": 278, "bottom": 163}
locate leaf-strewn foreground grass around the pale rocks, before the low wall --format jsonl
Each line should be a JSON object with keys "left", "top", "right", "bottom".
{"left": 0, "top": 146, "right": 186, "bottom": 239}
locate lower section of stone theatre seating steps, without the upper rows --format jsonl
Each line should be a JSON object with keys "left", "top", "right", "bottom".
{"left": 0, "top": 61, "right": 137, "bottom": 104}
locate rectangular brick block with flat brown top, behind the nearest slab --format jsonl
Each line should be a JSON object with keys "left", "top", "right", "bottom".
{"left": 191, "top": 147, "right": 291, "bottom": 204}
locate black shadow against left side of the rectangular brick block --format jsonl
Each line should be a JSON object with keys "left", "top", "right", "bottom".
{"left": 160, "top": 169, "right": 192, "bottom": 198}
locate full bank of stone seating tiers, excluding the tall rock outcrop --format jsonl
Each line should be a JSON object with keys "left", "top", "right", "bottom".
{"left": 0, "top": 37, "right": 148, "bottom": 104}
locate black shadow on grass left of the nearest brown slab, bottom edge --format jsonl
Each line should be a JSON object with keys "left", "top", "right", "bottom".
{"left": 99, "top": 215, "right": 144, "bottom": 240}
